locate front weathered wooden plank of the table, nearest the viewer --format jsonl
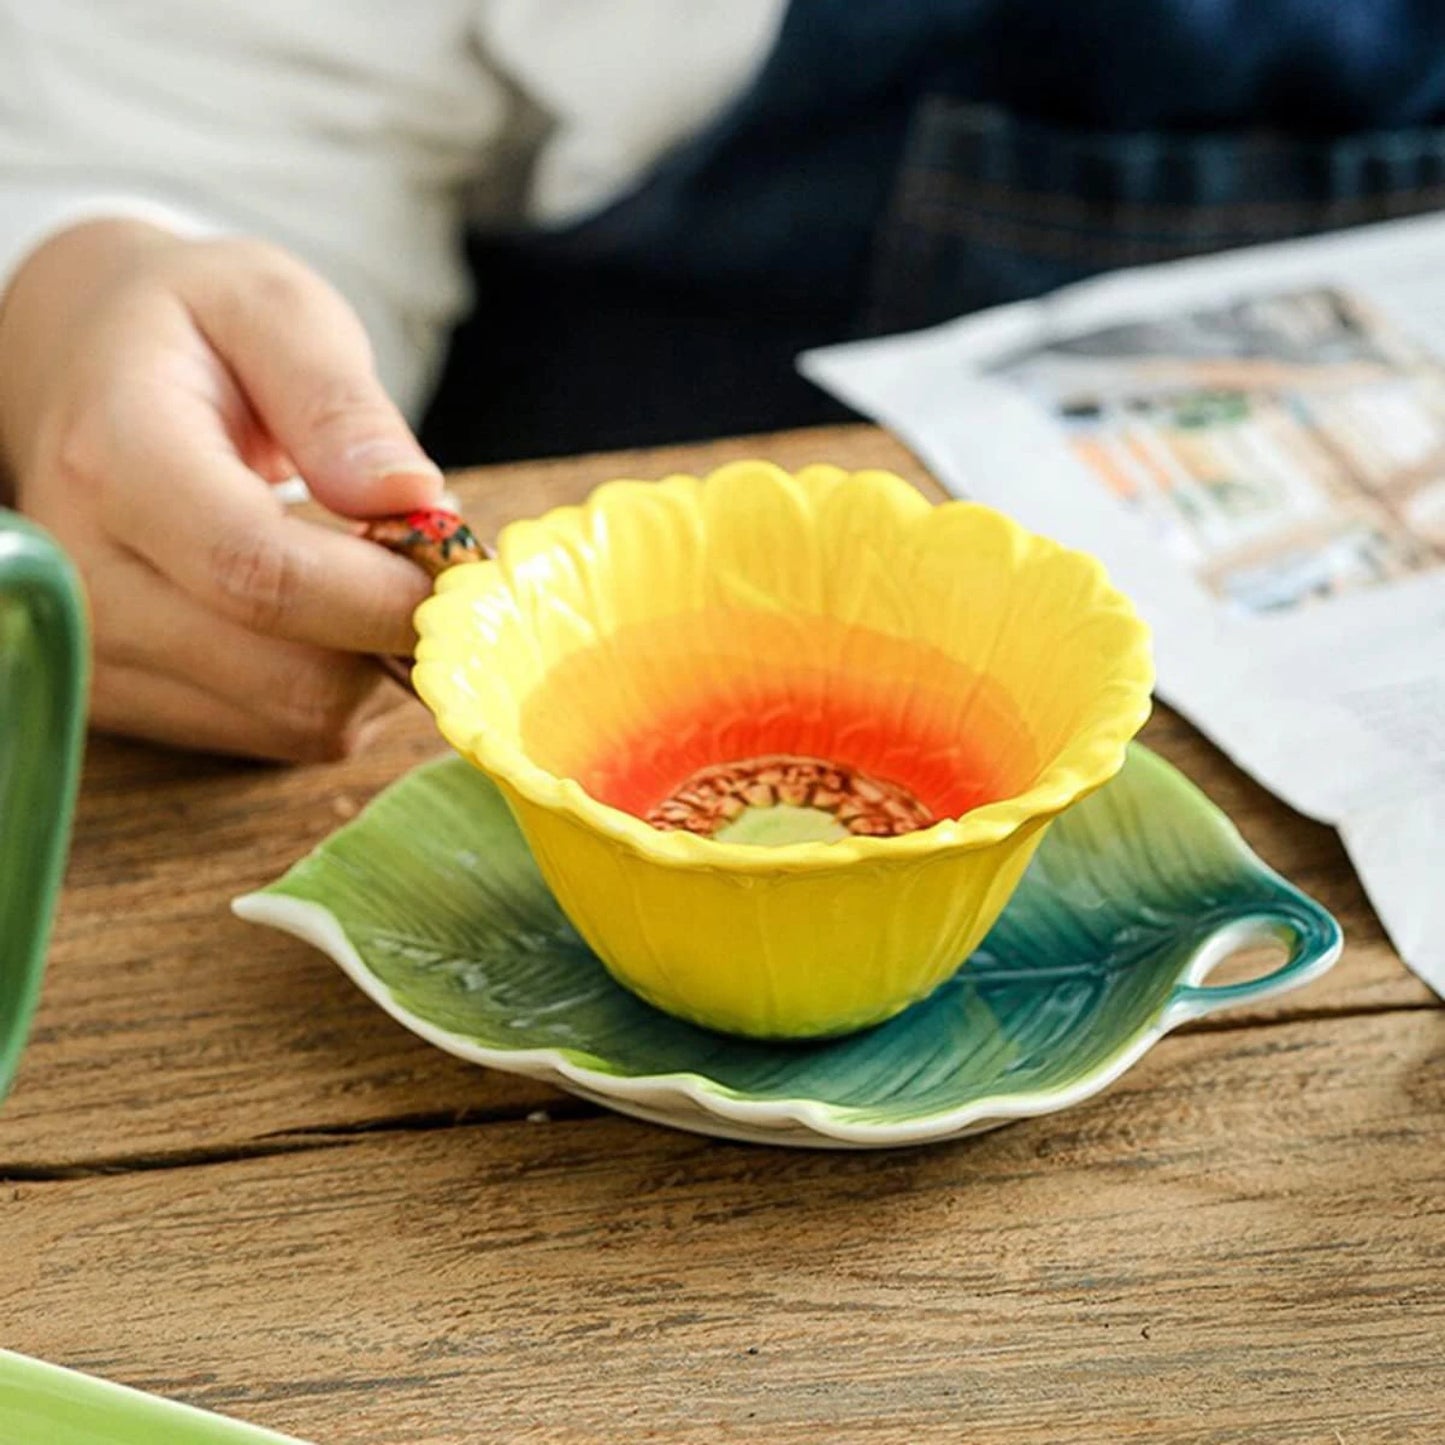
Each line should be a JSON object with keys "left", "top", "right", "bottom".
{"left": 0, "top": 1010, "right": 1445, "bottom": 1445}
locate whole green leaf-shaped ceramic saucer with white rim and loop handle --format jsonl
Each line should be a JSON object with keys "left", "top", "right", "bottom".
{"left": 236, "top": 746, "right": 1341, "bottom": 1147}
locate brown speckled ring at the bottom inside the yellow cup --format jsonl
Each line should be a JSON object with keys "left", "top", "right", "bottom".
{"left": 646, "top": 754, "right": 938, "bottom": 838}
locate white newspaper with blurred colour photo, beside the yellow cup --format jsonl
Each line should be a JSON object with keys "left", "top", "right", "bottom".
{"left": 799, "top": 217, "right": 1445, "bottom": 996}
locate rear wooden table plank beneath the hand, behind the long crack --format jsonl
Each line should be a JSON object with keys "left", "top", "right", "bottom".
{"left": 0, "top": 428, "right": 1431, "bottom": 1173}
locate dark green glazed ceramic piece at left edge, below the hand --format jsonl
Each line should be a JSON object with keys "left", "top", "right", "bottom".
{"left": 0, "top": 512, "right": 87, "bottom": 1100}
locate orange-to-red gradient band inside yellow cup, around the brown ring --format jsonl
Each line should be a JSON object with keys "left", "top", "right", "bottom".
{"left": 520, "top": 613, "right": 1039, "bottom": 819}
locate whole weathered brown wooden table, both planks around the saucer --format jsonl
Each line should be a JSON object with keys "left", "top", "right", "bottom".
{"left": 0, "top": 428, "right": 1445, "bottom": 1445}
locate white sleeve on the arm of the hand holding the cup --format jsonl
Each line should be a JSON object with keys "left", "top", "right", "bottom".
{"left": 0, "top": 0, "right": 514, "bottom": 415}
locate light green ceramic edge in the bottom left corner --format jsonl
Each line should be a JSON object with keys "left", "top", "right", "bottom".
{"left": 0, "top": 1350, "right": 313, "bottom": 1445}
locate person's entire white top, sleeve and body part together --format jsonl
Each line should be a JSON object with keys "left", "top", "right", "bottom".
{"left": 0, "top": 0, "right": 782, "bottom": 416}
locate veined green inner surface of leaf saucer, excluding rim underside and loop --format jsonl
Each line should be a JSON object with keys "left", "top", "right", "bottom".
{"left": 251, "top": 746, "right": 1340, "bottom": 1124}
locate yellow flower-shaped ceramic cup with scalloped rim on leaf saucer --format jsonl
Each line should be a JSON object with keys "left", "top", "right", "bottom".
{"left": 369, "top": 462, "right": 1153, "bottom": 1039}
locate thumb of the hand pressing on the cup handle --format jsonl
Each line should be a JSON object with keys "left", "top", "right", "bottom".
{"left": 197, "top": 244, "right": 442, "bottom": 517}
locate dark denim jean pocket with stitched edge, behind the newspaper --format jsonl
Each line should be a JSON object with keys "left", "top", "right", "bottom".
{"left": 863, "top": 97, "right": 1445, "bottom": 334}
